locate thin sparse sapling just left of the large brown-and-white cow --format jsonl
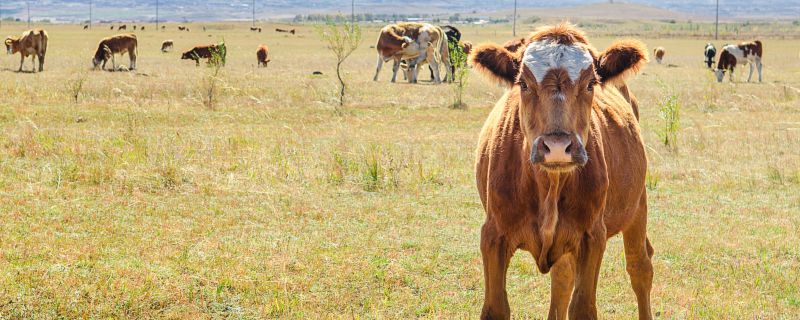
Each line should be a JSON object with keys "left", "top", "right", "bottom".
{"left": 317, "top": 20, "right": 361, "bottom": 107}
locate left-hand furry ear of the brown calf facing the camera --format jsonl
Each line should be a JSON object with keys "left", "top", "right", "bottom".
{"left": 469, "top": 44, "right": 520, "bottom": 87}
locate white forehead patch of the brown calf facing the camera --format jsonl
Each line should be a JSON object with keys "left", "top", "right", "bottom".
{"left": 522, "top": 39, "right": 594, "bottom": 84}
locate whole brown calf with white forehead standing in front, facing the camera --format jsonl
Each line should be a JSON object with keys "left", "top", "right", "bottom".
{"left": 470, "top": 24, "right": 653, "bottom": 319}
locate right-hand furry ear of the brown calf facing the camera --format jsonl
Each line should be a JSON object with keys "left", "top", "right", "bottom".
{"left": 596, "top": 40, "right": 648, "bottom": 85}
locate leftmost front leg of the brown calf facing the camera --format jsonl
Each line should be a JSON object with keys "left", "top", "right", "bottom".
{"left": 481, "top": 220, "right": 516, "bottom": 319}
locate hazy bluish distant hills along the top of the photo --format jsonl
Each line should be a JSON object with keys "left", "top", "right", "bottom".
{"left": 0, "top": 0, "right": 800, "bottom": 22}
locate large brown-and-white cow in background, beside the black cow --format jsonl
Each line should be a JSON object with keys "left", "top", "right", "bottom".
{"left": 373, "top": 22, "right": 452, "bottom": 83}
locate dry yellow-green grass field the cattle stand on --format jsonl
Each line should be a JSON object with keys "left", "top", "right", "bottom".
{"left": 0, "top": 23, "right": 800, "bottom": 319}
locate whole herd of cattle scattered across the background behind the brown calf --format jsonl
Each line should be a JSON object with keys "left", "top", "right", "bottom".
{"left": 5, "top": 22, "right": 763, "bottom": 83}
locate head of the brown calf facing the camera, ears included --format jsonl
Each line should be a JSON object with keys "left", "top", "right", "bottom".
{"left": 470, "top": 24, "right": 647, "bottom": 172}
